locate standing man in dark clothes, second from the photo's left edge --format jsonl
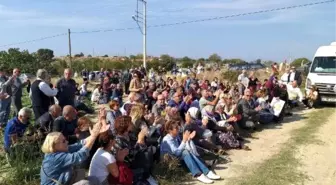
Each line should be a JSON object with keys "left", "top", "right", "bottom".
{"left": 12, "top": 68, "right": 28, "bottom": 117}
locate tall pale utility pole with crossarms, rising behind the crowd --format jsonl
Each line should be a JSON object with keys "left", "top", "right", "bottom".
{"left": 132, "top": 0, "right": 147, "bottom": 69}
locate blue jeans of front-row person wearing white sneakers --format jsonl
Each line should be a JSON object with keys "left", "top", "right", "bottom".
{"left": 181, "top": 150, "right": 209, "bottom": 177}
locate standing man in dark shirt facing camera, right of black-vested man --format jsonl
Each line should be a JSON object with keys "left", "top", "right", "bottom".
{"left": 56, "top": 69, "right": 77, "bottom": 108}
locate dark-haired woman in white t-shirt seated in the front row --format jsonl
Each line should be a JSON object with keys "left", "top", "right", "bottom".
{"left": 89, "top": 130, "right": 133, "bottom": 185}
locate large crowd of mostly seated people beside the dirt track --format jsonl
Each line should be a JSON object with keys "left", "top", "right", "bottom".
{"left": 0, "top": 65, "right": 318, "bottom": 185}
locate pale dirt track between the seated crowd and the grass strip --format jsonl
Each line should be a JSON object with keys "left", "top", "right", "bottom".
{"left": 192, "top": 111, "right": 309, "bottom": 185}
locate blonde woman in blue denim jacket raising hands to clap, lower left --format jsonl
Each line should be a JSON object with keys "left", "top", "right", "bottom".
{"left": 40, "top": 123, "right": 101, "bottom": 185}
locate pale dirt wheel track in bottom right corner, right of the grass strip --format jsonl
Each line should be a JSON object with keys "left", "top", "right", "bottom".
{"left": 297, "top": 113, "right": 336, "bottom": 185}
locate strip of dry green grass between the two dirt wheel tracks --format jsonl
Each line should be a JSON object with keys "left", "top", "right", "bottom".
{"left": 229, "top": 108, "right": 334, "bottom": 185}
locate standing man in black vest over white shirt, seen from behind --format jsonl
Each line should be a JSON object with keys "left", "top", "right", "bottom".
{"left": 30, "top": 69, "right": 58, "bottom": 120}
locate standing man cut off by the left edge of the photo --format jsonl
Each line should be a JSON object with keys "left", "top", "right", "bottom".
{"left": 0, "top": 70, "right": 15, "bottom": 127}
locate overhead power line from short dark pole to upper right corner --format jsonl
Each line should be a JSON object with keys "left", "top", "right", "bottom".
{"left": 73, "top": 0, "right": 336, "bottom": 33}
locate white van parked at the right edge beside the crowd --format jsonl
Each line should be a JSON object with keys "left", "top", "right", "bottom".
{"left": 306, "top": 42, "right": 336, "bottom": 103}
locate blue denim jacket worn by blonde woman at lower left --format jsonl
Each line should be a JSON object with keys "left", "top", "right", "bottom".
{"left": 40, "top": 143, "right": 90, "bottom": 185}
